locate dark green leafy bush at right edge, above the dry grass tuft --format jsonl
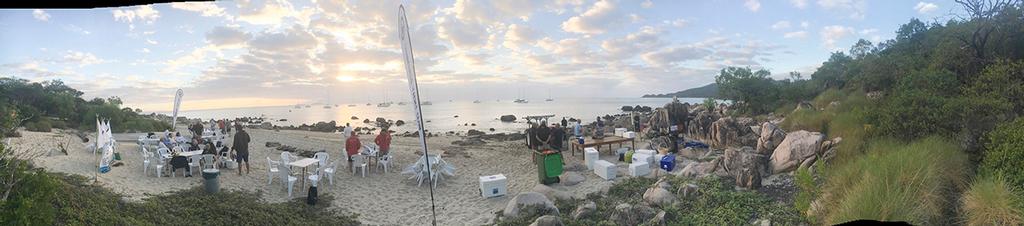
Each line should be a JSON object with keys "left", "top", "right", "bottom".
{"left": 978, "top": 118, "right": 1024, "bottom": 190}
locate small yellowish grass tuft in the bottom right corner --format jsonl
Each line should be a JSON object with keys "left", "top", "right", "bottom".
{"left": 961, "top": 176, "right": 1024, "bottom": 225}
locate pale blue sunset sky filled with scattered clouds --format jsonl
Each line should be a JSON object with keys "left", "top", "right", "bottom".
{"left": 0, "top": 0, "right": 961, "bottom": 111}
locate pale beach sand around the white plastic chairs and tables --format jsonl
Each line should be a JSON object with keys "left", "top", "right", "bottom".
{"left": 9, "top": 127, "right": 638, "bottom": 225}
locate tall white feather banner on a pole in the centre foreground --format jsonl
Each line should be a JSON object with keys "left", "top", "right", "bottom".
{"left": 398, "top": 5, "right": 437, "bottom": 225}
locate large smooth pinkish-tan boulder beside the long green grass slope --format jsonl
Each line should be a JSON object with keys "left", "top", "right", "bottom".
{"left": 771, "top": 130, "right": 824, "bottom": 174}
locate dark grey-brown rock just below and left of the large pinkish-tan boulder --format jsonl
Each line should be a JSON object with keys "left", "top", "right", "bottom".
{"left": 722, "top": 146, "right": 768, "bottom": 189}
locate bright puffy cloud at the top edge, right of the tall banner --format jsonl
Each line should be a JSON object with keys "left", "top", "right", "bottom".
{"left": 562, "top": 0, "right": 626, "bottom": 34}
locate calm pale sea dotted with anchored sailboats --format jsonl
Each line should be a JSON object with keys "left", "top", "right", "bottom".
{"left": 162, "top": 98, "right": 703, "bottom": 132}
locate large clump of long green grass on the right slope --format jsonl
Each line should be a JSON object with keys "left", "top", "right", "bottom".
{"left": 822, "top": 137, "right": 969, "bottom": 225}
